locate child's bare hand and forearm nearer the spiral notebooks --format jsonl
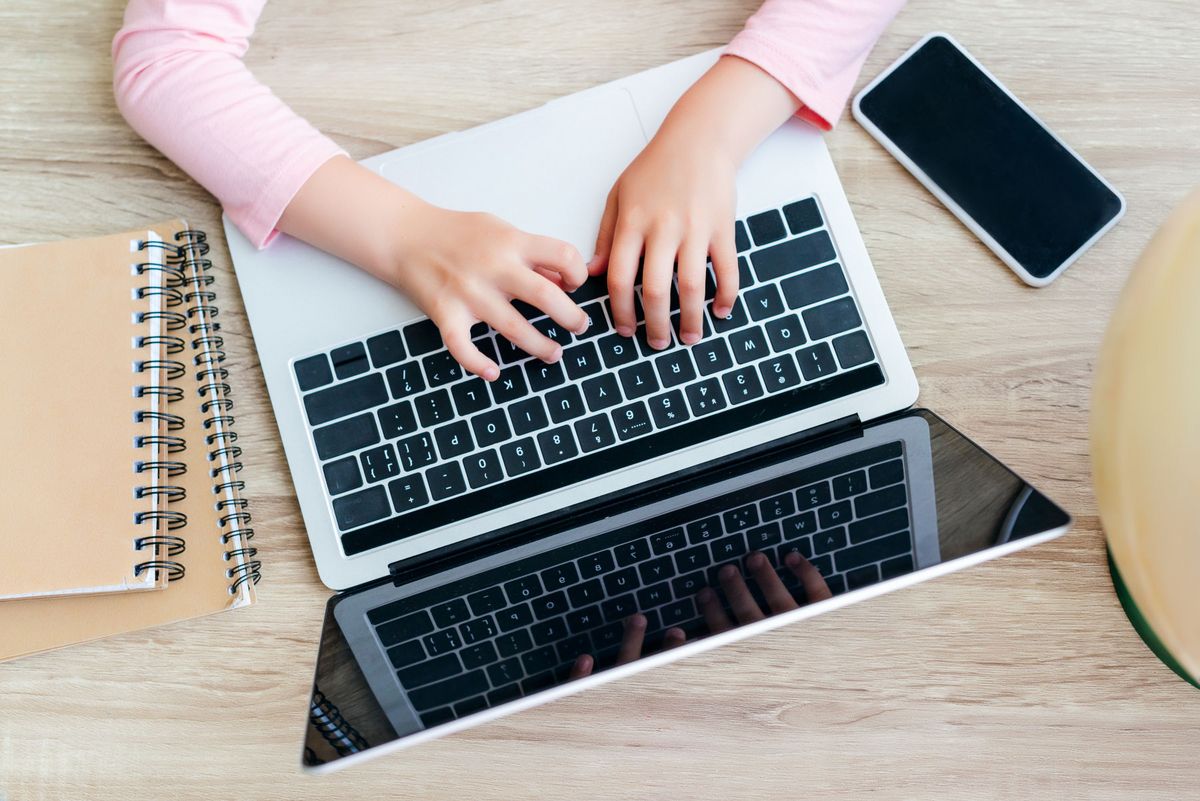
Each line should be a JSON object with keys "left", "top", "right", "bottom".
{"left": 278, "top": 157, "right": 588, "bottom": 381}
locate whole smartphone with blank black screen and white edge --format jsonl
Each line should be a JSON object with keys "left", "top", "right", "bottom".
{"left": 853, "top": 34, "right": 1124, "bottom": 287}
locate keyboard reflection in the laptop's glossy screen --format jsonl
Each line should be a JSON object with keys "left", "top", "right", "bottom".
{"left": 367, "top": 441, "right": 914, "bottom": 727}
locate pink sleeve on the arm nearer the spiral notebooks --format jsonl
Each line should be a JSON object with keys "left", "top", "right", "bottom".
{"left": 113, "top": 0, "right": 344, "bottom": 247}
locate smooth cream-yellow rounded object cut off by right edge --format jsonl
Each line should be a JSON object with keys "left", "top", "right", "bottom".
{"left": 1091, "top": 189, "right": 1200, "bottom": 682}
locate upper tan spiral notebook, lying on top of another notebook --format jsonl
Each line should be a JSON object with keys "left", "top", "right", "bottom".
{"left": 0, "top": 231, "right": 167, "bottom": 602}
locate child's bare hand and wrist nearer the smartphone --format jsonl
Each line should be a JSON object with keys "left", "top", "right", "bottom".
{"left": 588, "top": 56, "right": 799, "bottom": 349}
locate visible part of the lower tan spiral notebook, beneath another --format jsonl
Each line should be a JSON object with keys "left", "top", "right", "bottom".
{"left": 0, "top": 221, "right": 258, "bottom": 660}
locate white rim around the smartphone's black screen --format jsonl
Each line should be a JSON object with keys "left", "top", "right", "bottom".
{"left": 851, "top": 31, "right": 1126, "bottom": 287}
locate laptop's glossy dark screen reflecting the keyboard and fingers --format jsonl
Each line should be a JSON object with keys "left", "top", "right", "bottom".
{"left": 304, "top": 410, "right": 1070, "bottom": 769}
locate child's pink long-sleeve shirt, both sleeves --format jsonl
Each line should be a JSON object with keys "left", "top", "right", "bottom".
{"left": 113, "top": 0, "right": 905, "bottom": 247}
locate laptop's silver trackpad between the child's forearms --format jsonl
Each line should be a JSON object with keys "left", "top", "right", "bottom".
{"left": 379, "top": 88, "right": 647, "bottom": 259}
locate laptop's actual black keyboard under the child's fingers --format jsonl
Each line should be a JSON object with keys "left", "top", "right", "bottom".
{"left": 293, "top": 197, "right": 883, "bottom": 555}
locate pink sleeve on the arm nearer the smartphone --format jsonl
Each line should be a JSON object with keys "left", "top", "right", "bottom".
{"left": 725, "top": 0, "right": 905, "bottom": 131}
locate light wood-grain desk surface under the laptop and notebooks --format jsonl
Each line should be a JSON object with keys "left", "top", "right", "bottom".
{"left": 0, "top": 0, "right": 1200, "bottom": 801}
